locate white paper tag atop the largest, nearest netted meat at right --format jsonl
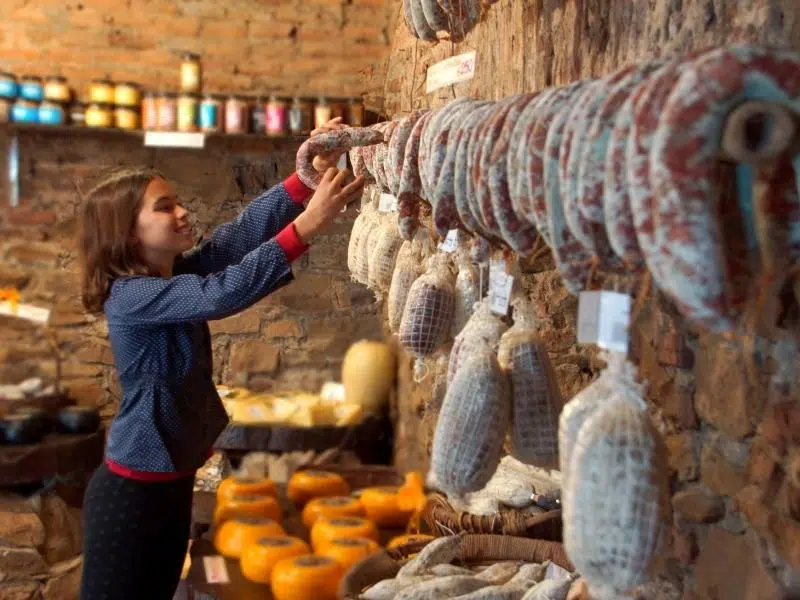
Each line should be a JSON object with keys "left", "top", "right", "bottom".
{"left": 578, "top": 292, "right": 631, "bottom": 352}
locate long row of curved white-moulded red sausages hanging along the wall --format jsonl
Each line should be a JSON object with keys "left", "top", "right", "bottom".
{"left": 342, "top": 45, "right": 800, "bottom": 331}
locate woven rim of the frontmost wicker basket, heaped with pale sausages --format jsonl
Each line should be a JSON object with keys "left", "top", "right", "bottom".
{"left": 339, "top": 534, "right": 575, "bottom": 600}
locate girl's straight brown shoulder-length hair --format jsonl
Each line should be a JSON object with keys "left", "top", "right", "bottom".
{"left": 78, "top": 167, "right": 164, "bottom": 313}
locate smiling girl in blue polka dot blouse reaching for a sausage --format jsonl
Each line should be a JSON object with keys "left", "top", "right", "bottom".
{"left": 79, "top": 120, "right": 364, "bottom": 600}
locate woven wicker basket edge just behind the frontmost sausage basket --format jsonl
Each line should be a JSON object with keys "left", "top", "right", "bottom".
{"left": 422, "top": 494, "right": 562, "bottom": 542}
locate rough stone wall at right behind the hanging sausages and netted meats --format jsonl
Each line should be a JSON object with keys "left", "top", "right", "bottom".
{"left": 366, "top": 0, "right": 800, "bottom": 600}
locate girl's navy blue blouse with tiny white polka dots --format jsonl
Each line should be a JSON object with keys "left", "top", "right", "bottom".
{"left": 104, "top": 184, "right": 302, "bottom": 472}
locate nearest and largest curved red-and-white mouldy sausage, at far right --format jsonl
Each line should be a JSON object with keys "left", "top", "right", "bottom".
{"left": 648, "top": 46, "right": 800, "bottom": 331}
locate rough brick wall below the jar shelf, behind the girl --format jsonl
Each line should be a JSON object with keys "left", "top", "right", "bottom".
{"left": 0, "top": 127, "right": 380, "bottom": 415}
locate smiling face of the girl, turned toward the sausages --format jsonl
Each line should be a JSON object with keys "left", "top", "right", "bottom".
{"left": 134, "top": 177, "right": 194, "bottom": 265}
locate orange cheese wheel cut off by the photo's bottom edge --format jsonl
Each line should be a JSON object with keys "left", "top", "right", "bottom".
{"left": 271, "top": 554, "right": 344, "bottom": 600}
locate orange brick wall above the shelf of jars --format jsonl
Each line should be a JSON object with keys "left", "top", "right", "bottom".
{"left": 0, "top": 0, "right": 389, "bottom": 96}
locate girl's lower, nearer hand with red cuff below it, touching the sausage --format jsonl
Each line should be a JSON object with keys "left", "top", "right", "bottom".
{"left": 294, "top": 167, "right": 364, "bottom": 244}
